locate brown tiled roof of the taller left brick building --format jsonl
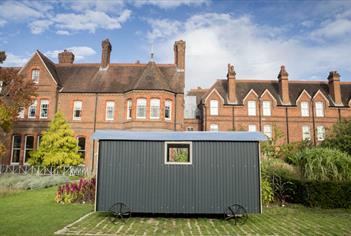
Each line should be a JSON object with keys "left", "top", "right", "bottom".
{"left": 38, "top": 51, "right": 184, "bottom": 93}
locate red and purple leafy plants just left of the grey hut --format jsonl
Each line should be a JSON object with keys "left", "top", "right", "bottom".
{"left": 55, "top": 177, "right": 96, "bottom": 203}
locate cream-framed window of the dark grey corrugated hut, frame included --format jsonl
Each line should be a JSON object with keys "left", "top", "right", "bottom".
{"left": 165, "top": 142, "right": 192, "bottom": 164}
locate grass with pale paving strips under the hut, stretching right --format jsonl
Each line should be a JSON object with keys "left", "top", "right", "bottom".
{"left": 58, "top": 205, "right": 351, "bottom": 236}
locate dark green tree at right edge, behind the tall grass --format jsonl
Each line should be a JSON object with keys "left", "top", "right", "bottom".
{"left": 321, "top": 119, "right": 351, "bottom": 155}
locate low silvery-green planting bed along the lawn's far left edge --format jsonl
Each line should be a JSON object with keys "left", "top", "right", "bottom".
{"left": 0, "top": 174, "right": 69, "bottom": 190}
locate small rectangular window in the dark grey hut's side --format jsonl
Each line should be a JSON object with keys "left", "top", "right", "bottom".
{"left": 167, "top": 144, "right": 190, "bottom": 163}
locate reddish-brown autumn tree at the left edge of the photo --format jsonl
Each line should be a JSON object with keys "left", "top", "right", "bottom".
{"left": 0, "top": 52, "right": 36, "bottom": 157}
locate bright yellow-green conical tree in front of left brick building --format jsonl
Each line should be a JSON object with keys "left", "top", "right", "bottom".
{"left": 28, "top": 112, "right": 82, "bottom": 167}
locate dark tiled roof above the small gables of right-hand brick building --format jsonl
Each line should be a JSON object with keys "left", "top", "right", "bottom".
{"left": 195, "top": 80, "right": 351, "bottom": 106}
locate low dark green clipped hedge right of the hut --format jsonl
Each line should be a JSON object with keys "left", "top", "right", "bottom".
{"left": 282, "top": 179, "right": 351, "bottom": 208}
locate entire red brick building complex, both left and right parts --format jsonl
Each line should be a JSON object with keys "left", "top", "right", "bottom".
{"left": 2, "top": 40, "right": 351, "bottom": 169}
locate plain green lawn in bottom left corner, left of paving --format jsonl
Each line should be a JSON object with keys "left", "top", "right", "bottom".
{"left": 0, "top": 187, "right": 93, "bottom": 236}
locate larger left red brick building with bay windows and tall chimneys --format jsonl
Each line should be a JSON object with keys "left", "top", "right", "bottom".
{"left": 3, "top": 40, "right": 185, "bottom": 169}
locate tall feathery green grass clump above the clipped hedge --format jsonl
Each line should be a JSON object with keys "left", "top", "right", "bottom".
{"left": 291, "top": 148, "right": 351, "bottom": 181}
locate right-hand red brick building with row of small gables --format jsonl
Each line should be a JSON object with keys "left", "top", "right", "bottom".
{"left": 184, "top": 65, "right": 351, "bottom": 143}
